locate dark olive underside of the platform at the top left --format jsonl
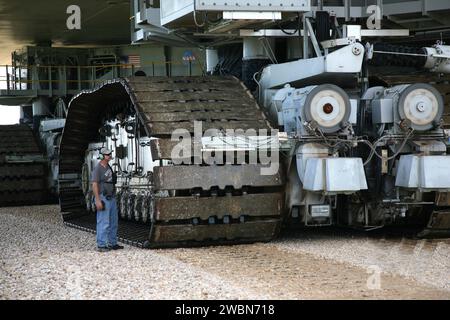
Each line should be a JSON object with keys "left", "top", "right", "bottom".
{"left": 0, "top": 0, "right": 131, "bottom": 65}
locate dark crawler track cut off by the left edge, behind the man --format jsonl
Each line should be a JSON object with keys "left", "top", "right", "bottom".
{"left": 0, "top": 125, "right": 46, "bottom": 206}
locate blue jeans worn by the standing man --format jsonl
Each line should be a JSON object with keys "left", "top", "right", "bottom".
{"left": 97, "top": 195, "right": 119, "bottom": 247}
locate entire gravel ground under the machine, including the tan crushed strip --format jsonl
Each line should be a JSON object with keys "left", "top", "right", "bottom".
{"left": 0, "top": 206, "right": 450, "bottom": 300}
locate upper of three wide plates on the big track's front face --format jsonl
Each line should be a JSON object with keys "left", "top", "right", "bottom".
{"left": 154, "top": 165, "right": 283, "bottom": 190}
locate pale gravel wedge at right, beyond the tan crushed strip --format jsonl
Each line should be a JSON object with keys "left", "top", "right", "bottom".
{"left": 271, "top": 230, "right": 450, "bottom": 297}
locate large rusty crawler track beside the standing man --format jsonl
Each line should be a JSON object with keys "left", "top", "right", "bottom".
{"left": 60, "top": 77, "right": 283, "bottom": 247}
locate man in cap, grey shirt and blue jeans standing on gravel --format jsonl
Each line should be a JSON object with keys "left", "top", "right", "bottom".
{"left": 91, "top": 148, "right": 123, "bottom": 252}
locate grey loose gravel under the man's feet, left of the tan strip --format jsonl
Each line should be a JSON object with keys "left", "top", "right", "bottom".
{"left": 0, "top": 206, "right": 264, "bottom": 299}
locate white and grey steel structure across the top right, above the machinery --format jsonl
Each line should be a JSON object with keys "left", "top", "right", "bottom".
{"left": 132, "top": 0, "right": 450, "bottom": 45}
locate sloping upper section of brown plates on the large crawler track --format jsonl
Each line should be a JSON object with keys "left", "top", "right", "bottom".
{"left": 128, "top": 77, "right": 270, "bottom": 137}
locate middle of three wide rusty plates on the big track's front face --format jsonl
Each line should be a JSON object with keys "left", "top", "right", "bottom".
{"left": 155, "top": 193, "right": 282, "bottom": 221}
